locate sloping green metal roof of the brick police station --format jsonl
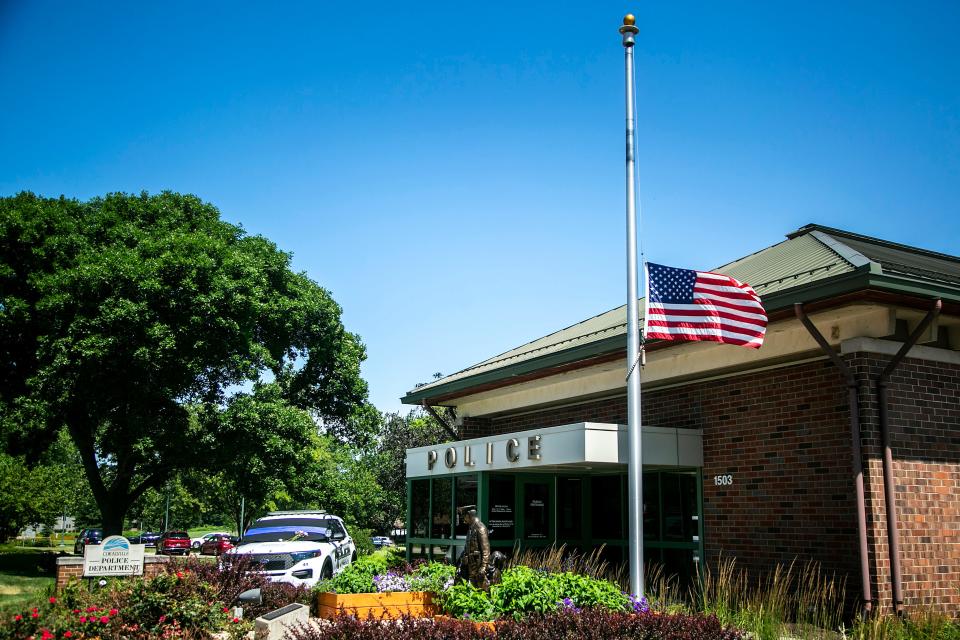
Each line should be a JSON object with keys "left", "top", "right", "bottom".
{"left": 401, "top": 224, "right": 960, "bottom": 404}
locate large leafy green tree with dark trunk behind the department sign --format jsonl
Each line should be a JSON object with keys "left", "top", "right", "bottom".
{"left": 0, "top": 193, "right": 367, "bottom": 533}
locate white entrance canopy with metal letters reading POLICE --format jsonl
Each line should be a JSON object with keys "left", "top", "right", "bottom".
{"left": 406, "top": 422, "right": 703, "bottom": 478}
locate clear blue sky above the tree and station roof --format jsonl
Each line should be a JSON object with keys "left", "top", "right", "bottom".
{"left": 0, "top": 0, "right": 960, "bottom": 410}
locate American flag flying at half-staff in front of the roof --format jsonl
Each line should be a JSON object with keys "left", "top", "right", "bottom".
{"left": 644, "top": 263, "right": 767, "bottom": 349}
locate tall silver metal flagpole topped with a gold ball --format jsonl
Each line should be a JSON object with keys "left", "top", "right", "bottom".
{"left": 620, "top": 14, "right": 644, "bottom": 598}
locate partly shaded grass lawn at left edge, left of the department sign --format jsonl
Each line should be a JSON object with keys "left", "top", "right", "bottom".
{"left": 0, "top": 544, "right": 56, "bottom": 612}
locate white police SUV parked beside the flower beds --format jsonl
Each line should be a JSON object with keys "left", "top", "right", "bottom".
{"left": 221, "top": 511, "right": 357, "bottom": 587}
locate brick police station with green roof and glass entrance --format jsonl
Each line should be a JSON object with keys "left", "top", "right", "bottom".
{"left": 403, "top": 225, "right": 960, "bottom": 611}
